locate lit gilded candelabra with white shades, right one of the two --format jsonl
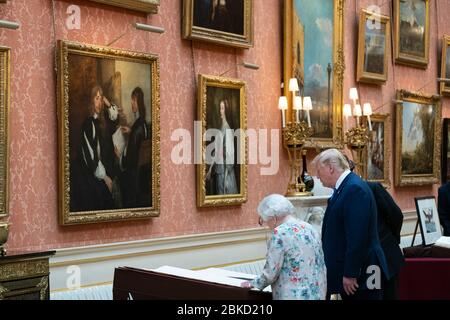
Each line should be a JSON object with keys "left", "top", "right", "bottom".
{"left": 342, "top": 88, "right": 372, "bottom": 178}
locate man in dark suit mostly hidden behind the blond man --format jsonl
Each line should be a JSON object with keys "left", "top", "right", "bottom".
{"left": 367, "top": 182, "right": 405, "bottom": 300}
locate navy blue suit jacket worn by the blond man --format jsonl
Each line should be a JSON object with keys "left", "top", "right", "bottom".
{"left": 322, "top": 172, "right": 389, "bottom": 294}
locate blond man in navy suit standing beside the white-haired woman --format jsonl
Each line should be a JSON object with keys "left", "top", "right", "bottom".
{"left": 313, "top": 149, "right": 388, "bottom": 300}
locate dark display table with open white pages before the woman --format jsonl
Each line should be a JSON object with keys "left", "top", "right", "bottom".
{"left": 113, "top": 266, "right": 272, "bottom": 300}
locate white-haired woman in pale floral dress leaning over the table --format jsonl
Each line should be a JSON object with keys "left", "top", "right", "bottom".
{"left": 241, "top": 194, "right": 327, "bottom": 300}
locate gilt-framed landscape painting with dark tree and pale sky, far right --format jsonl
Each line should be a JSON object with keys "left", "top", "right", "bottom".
{"left": 395, "top": 90, "right": 441, "bottom": 186}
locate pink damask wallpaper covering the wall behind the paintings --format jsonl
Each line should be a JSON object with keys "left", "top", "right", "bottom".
{"left": 0, "top": 0, "right": 450, "bottom": 250}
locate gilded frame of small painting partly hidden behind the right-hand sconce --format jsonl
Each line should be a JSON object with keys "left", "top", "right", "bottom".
{"left": 365, "top": 114, "right": 391, "bottom": 188}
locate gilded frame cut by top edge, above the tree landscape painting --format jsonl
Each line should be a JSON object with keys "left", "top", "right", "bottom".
{"left": 394, "top": 0, "right": 430, "bottom": 69}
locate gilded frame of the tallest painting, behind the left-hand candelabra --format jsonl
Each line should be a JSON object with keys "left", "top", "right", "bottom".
{"left": 283, "top": 0, "right": 345, "bottom": 149}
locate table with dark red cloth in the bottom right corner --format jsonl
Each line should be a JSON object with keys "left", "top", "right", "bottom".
{"left": 399, "top": 246, "right": 450, "bottom": 300}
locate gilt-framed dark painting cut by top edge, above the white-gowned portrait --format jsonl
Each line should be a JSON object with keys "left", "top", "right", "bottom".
{"left": 182, "top": 0, "right": 253, "bottom": 48}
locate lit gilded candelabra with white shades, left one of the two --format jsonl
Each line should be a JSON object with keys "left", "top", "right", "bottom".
{"left": 278, "top": 78, "right": 314, "bottom": 197}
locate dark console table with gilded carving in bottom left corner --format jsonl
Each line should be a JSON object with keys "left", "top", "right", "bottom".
{"left": 0, "top": 251, "right": 55, "bottom": 300}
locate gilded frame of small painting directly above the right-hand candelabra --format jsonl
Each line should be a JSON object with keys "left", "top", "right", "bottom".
{"left": 356, "top": 10, "right": 391, "bottom": 84}
